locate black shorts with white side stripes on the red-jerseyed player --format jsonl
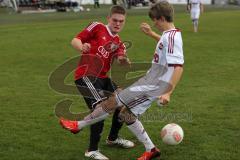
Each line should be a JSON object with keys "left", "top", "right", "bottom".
{"left": 75, "top": 76, "right": 118, "bottom": 109}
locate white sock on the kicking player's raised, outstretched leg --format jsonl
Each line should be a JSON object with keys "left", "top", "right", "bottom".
{"left": 78, "top": 107, "right": 109, "bottom": 129}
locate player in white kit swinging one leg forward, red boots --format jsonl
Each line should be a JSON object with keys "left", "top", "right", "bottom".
{"left": 60, "top": 2, "right": 184, "bottom": 160}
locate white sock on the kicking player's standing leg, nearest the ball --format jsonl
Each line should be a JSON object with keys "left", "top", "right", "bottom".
{"left": 127, "top": 119, "right": 155, "bottom": 151}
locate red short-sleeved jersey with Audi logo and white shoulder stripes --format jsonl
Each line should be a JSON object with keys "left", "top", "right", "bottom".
{"left": 75, "top": 22, "right": 126, "bottom": 80}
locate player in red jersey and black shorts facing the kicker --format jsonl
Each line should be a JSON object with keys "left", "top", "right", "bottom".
{"left": 71, "top": 6, "right": 134, "bottom": 160}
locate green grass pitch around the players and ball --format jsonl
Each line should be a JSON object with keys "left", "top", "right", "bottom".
{"left": 0, "top": 7, "right": 240, "bottom": 160}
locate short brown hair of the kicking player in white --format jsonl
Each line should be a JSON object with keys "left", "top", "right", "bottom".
{"left": 148, "top": 1, "right": 174, "bottom": 22}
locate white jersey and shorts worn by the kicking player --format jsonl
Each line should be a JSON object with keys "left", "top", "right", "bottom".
{"left": 116, "top": 29, "right": 184, "bottom": 116}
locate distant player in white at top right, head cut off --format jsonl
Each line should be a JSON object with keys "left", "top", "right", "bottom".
{"left": 188, "top": 0, "right": 203, "bottom": 32}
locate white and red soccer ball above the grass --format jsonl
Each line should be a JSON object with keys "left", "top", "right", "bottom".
{"left": 161, "top": 123, "right": 184, "bottom": 145}
